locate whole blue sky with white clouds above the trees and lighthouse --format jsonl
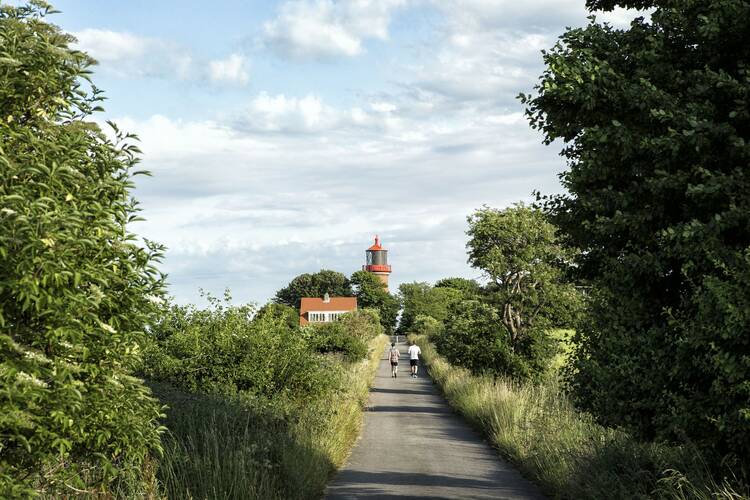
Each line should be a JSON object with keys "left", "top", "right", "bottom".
{"left": 49, "top": 0, "right": 648, "bottom": 304}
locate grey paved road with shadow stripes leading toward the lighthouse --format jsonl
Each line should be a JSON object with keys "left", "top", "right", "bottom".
{"left": 326, "top": 344, "right": 544, "bottom": 499}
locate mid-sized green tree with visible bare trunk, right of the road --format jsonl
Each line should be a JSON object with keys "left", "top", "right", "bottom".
{"left": 466, "top": 204, "right": 577, "bottom": 347}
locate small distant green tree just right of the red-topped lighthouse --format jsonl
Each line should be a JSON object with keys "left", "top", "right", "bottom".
{"left": 398, "top": 278, "right": 467, "bottom": 334}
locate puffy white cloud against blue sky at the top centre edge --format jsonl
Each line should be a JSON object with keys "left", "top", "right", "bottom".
{"left": 263, "top": 0, "right": 404, "bottom": 59}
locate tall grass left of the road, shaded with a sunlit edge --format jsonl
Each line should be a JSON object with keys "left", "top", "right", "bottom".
{"left": 151, "top": 335, "right": 387, "bottom": 499}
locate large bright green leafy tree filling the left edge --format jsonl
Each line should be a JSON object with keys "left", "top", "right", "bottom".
{"left": 0, "top": 2, "right": 163, "bottom": 498}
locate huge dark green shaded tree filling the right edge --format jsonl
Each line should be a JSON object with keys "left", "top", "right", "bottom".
{"left": 522, "top": 0, "right": 750, "bottom": 456}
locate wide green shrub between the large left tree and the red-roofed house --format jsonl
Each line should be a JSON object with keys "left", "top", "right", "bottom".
{"left": 143, "top": 296, "right": 337, "bottom": 405}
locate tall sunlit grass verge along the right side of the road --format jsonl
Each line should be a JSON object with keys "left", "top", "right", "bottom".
{"left": 416, "top": 337, "right": 748, "bottom": 499}
